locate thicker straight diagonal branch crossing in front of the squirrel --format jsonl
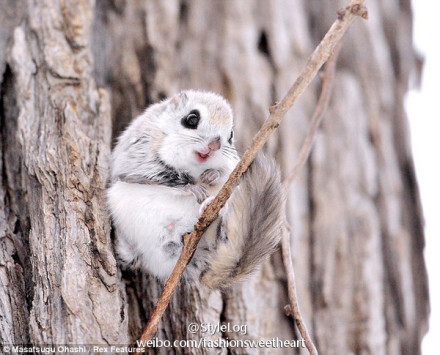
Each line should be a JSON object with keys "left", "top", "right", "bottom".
{"left": 138, "top": 0, "right": 367, "bottom": 345}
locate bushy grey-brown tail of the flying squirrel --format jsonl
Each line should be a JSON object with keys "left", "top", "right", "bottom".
{"left": 201, "top": 154, "right": 283, "bottom": 288}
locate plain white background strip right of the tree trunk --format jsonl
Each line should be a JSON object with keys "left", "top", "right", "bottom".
{"left": 406, "top": 0, "right": 440, "bottom": 355}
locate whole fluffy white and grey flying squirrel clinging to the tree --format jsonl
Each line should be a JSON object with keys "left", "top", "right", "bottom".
{"left": 107, "top": 90, "right": 282, "bottom": 289}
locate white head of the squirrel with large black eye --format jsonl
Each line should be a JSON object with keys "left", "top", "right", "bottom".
{"left": 154, "top": 90, "right": 237, "bottom": 177}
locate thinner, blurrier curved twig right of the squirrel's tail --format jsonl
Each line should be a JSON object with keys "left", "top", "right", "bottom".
{"left": 281, "top": 43, "right": 341, "bottom": 355}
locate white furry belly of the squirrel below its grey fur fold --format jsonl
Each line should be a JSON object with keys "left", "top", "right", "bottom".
{"left": 107, "top": 181, "right": 200, "bottom": 280}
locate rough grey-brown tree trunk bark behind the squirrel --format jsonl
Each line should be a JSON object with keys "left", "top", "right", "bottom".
{"left": 0, "top": 0, "right": 428, "bottom": 354}
